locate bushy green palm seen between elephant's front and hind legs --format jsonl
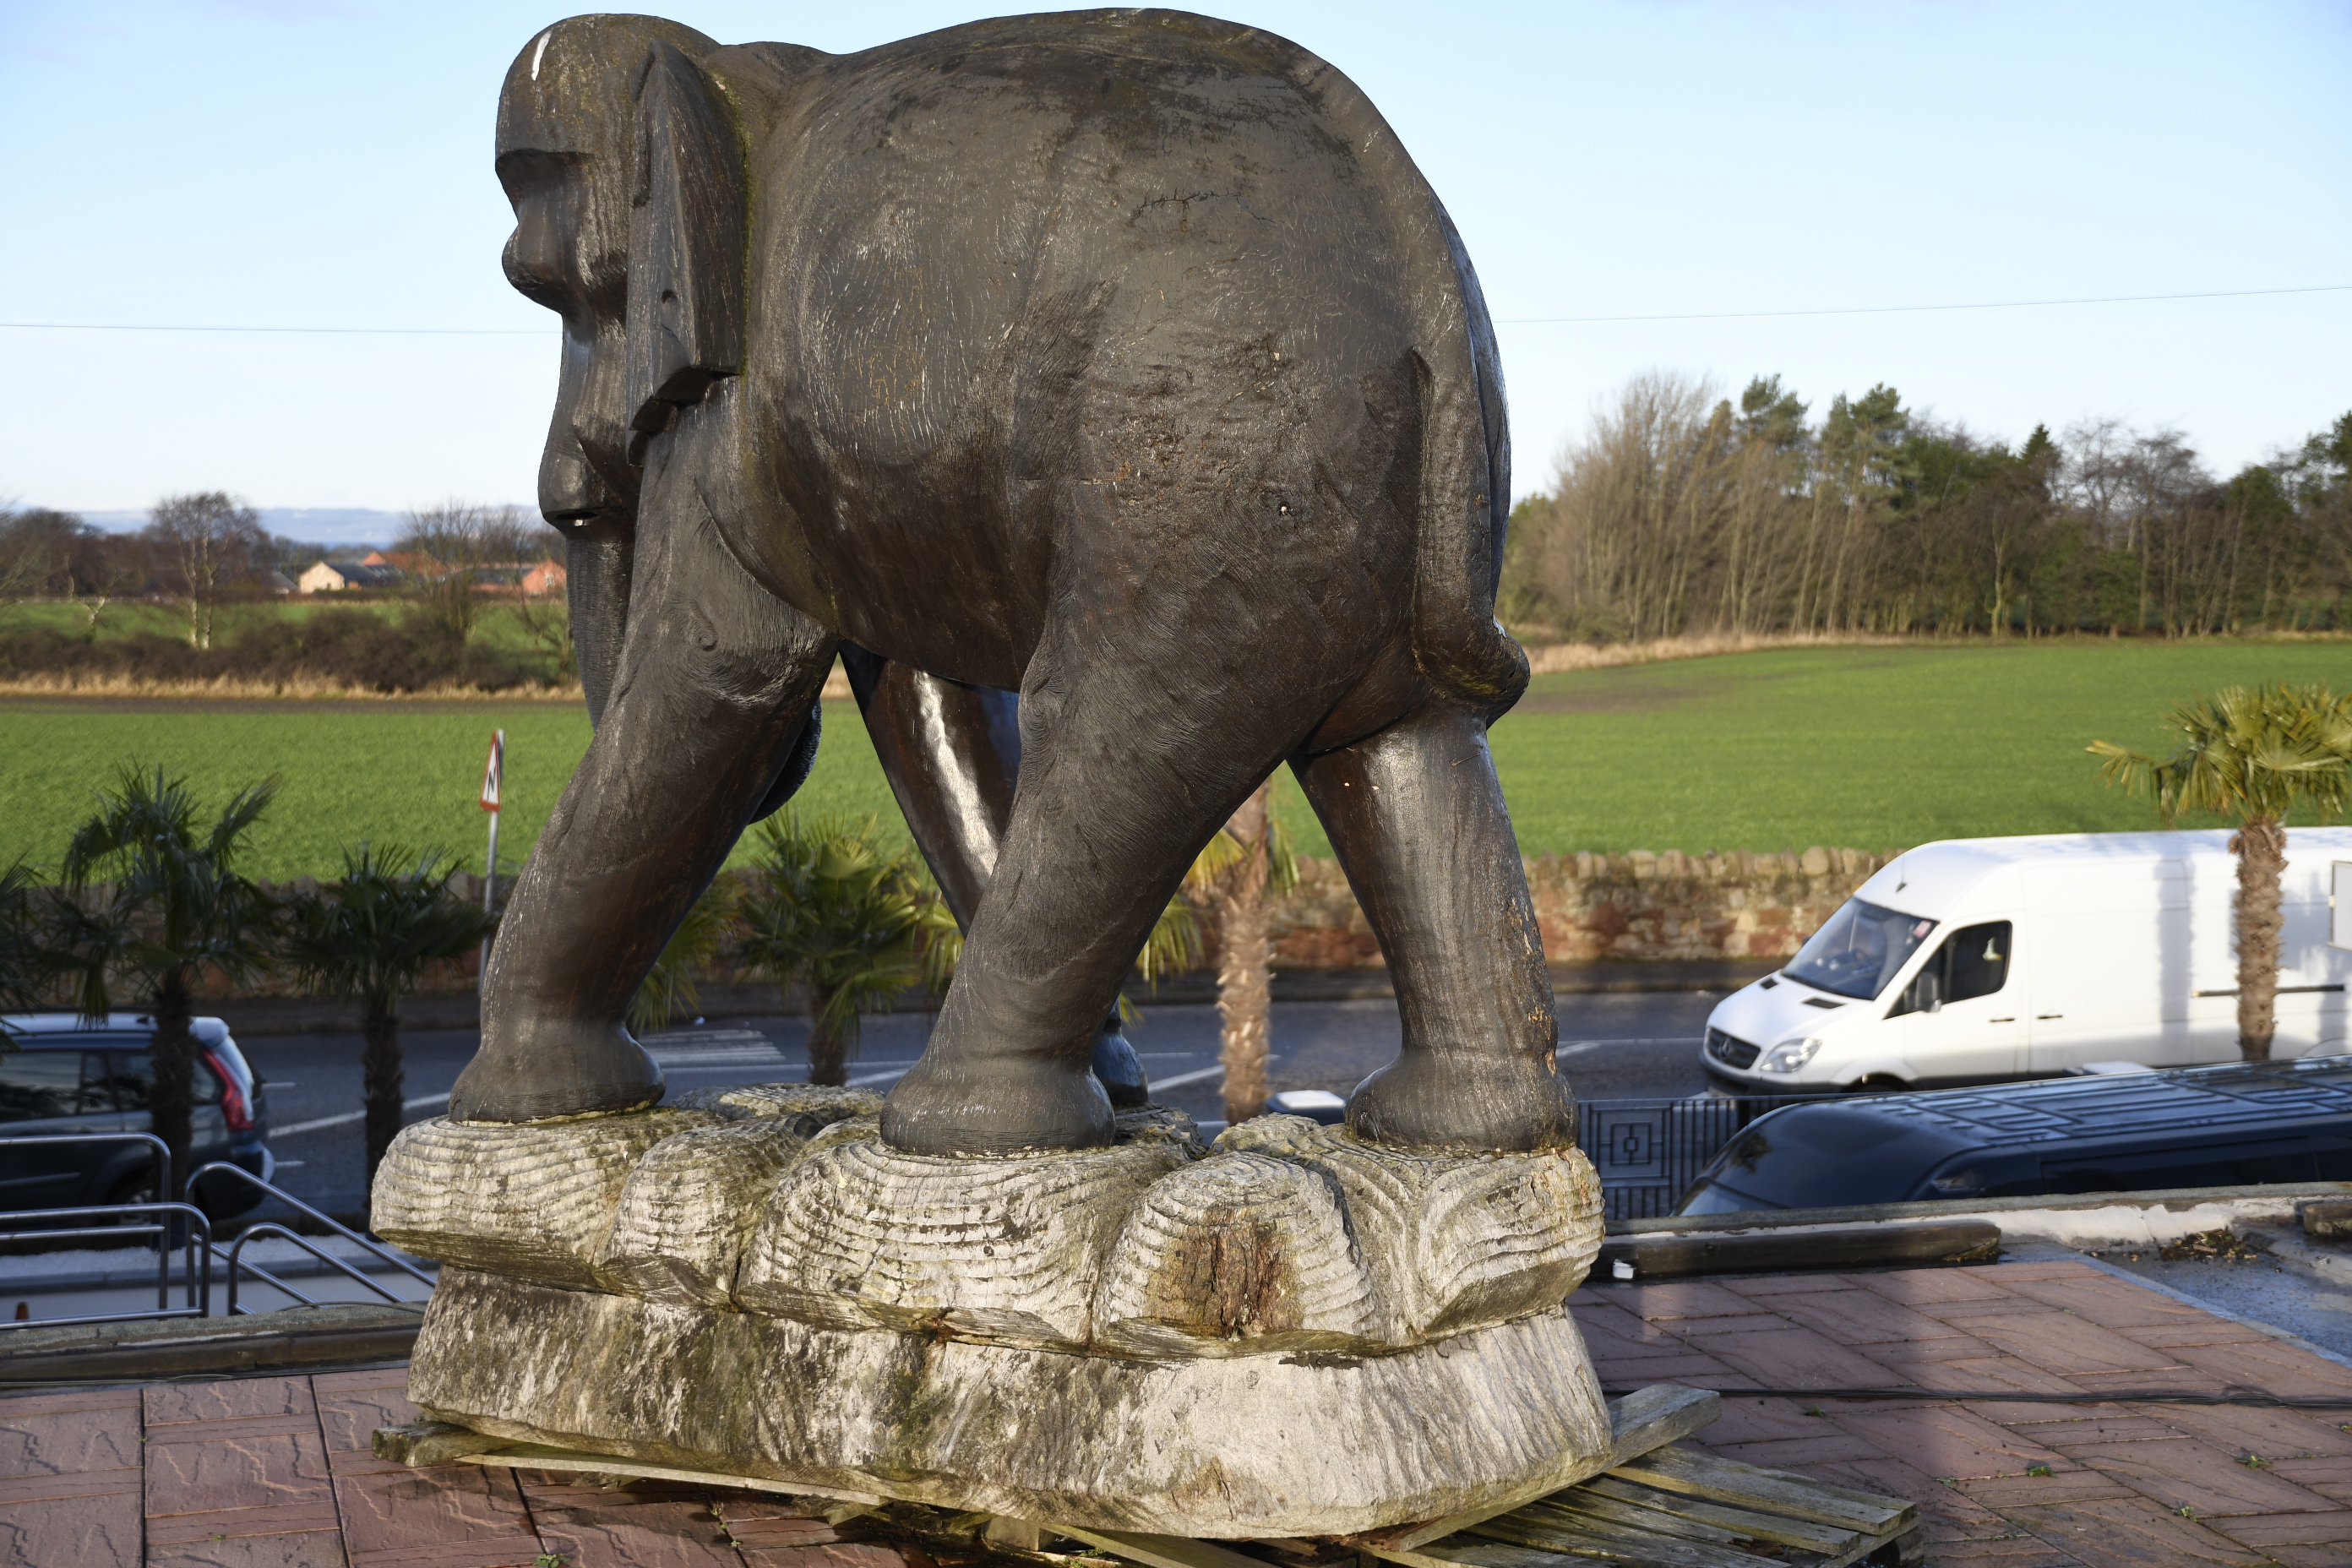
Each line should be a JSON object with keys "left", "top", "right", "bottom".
{"left": 736, "top": 808, "right": 929, "bottom": 1084}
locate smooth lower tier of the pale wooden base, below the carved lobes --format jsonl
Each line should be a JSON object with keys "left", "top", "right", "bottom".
{"left": 409, "top": 1269, "right": 1611, "bottom": 1538}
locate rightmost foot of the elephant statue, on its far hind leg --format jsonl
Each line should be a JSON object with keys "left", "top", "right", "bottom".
{"left": 1348, "top": 1051, "right": 1576, "bottom": 1152}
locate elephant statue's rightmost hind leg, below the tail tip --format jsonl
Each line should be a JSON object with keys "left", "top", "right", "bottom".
{"left": 1291, "top": 700, "right": 1576, "bottom": 1150}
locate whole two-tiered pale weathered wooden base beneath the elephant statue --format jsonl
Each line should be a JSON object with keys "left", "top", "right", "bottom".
{"left": 374, "top": 1086, "right": 1611, "bottom": 1538}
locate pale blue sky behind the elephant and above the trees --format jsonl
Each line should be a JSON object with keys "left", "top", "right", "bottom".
{"left": 0, "top": 0, "right": 2352, "bottom": 533}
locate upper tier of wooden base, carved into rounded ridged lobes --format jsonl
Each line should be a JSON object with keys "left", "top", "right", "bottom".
{"left": 376, "top": 1104, "right": 1602, "bottom": 1357}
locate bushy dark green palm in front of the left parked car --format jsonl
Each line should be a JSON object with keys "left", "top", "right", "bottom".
{"left": 57, "top": 766, "right": 278, "bottom": 1171}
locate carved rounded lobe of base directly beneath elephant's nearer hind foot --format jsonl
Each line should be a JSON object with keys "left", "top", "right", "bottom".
{"left": 736, "top": 1121, "right": 1185, "bottom": 1349}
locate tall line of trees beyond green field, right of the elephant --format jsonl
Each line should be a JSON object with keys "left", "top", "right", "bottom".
{"left": 1500, "top": 372, "right": 2352, "bottom": 642}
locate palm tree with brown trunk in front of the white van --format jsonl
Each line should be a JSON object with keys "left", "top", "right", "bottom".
{"left": 2091, "top": 684, "right": 2352, "bottom": 1063}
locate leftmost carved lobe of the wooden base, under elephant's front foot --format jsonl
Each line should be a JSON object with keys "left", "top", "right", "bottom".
{"left": 369, "top": 1109, "right": 717, "bottom": 1286}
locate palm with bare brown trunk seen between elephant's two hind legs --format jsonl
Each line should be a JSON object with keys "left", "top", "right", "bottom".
{"left": 1185, "top": 778, "right": 1298, "bottom": 1121}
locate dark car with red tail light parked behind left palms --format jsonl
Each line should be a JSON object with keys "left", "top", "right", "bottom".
{"left": 0, "top": 1013, "right": 275, "bottom": 1220}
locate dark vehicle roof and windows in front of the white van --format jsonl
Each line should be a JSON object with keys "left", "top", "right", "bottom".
{"left": 1674, "top": 1055, "right": 2352, "bottom": 1213}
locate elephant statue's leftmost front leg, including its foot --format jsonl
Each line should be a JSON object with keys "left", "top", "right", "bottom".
{"left": 449, "top": 472, "right": 835, "bottom": 1121}
